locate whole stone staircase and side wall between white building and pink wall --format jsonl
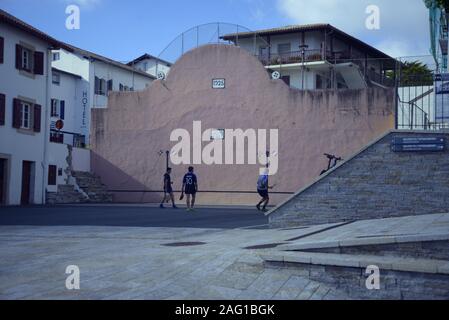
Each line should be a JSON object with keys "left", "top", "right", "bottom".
{"left": 47, "top": 171, "right": 112, "bottom": 205}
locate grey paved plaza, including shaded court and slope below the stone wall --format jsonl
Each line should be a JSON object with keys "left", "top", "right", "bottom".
{"left": 0, "top": 205, "right": 449, "bottom": 300}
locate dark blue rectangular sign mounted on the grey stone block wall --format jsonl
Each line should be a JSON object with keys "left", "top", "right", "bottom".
{"left": 391, "top": 137, "right": 446, "bottom": 152}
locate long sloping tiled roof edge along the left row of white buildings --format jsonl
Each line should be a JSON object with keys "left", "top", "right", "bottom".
{"left": 0, "top": 9, "right": 156, "bottom": 79}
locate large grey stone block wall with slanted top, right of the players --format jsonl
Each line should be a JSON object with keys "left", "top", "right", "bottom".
{"left": 269, "top": 132, "right": 449, "bottom": 227}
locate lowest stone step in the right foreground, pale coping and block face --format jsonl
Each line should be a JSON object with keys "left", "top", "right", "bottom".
{"left": 261, "top": 251, "right": 449, "bottom": 300}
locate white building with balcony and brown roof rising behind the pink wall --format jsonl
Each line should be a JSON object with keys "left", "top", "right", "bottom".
{"left": 222, "top": 24, "right": 395, "bottom": 90}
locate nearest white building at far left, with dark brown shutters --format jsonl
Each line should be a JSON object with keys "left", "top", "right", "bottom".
{"left": 0, "top": 10, "right": 72, "bottom": 205}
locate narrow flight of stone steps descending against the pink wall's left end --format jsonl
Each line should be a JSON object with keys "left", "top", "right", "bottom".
{"left": 72, "top": 171, "right": 112, "bottom": 203}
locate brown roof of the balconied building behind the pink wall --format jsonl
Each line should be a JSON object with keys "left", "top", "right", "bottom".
{"left": 221, "top": 23, "right": 394, "bottom": 60}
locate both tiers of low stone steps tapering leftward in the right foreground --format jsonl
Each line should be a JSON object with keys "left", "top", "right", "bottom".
{"left": 260, "top": 213, "right": 449, "bottom": 300}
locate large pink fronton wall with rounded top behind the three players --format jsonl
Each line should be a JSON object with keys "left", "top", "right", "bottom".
{"left": 91, "top": 45, "right": 394, "bottom": 204}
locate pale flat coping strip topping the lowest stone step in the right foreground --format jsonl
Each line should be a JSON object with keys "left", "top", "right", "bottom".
{"left": 261, "top": 252, "right": 449, "bottom": 275}
